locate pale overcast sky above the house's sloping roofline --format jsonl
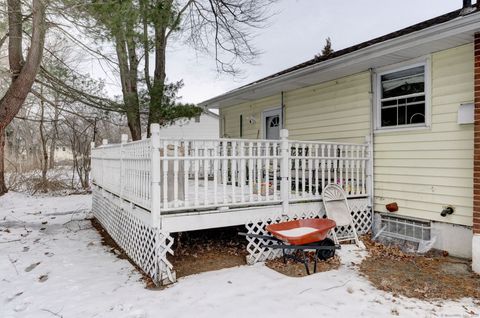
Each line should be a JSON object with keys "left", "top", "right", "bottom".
{"left": 93, "top": 0, "right": 462, "bottom": 103}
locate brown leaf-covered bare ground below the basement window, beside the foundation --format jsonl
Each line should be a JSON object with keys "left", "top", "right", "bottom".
{"left": 359, "top": 235, "right": 480, "bottom": 300}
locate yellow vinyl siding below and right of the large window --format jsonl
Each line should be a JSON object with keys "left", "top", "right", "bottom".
{"left": 374, "top": 45, "right": 473, "bottom": 225}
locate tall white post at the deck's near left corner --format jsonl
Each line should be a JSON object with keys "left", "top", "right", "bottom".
{"left": 150, "top": 124, "right": 161, "bottom": 228}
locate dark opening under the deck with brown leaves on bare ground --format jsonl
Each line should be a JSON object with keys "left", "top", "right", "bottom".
{"left": 168, "top": 227, "right": 247, "bottom": 278}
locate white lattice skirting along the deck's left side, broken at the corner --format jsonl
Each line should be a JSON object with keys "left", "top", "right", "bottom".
{"left": 92, "top": 186, "right": 175, "bottom": 285}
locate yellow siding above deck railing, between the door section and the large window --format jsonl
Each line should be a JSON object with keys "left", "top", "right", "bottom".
{"left": 284, "top": 72, "right": 370, "bottom": 143}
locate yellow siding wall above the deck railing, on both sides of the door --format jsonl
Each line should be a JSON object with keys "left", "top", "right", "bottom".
{"left": 220, "top": 72, "right": 370, "bottom": 143}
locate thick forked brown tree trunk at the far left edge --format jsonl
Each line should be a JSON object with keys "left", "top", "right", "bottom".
{"left": 0, "top": 0, "right": 46, "bottom": 195}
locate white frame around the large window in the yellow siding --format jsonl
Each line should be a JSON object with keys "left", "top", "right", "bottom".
{"left": 374, "top": 57, "right": 431, "bottom": 132}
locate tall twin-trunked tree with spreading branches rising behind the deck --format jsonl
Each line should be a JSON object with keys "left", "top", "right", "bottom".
{"left": 71, "top": 0, "right": 274, "bottom": 139}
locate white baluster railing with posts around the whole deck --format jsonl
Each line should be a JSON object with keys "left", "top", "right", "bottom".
{"left": 92, "top": 125, "right": 371, "bottom": 226}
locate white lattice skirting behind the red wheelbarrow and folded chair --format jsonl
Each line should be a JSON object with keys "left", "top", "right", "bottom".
{"left": 245, "top": 198, "right": 372, "bottom": 264}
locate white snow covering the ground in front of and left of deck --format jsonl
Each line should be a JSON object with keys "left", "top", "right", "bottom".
{"left": 0, "top": 193, "right": 480, "bottom": 318}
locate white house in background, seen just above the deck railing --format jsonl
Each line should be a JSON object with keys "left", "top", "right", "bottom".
{"left": 160, "top": 110, "right": 220, "bottom": 139}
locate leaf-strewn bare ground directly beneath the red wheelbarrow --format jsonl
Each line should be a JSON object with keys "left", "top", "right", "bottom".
{"left": 265, "top": 252, "right": 340, "bottom": 277}
